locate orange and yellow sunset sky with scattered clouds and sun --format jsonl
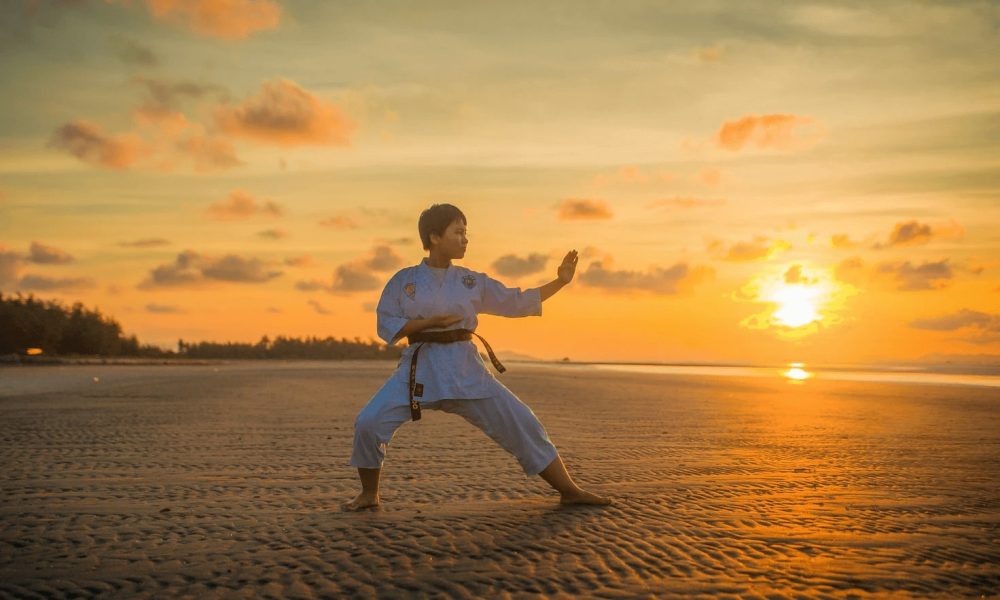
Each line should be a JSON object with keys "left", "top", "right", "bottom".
{"left": 0, "top": 0, "right": 1000, "bottom": 364}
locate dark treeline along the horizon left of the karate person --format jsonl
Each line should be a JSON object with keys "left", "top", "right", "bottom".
{"left": 0, "top": 293, "right": 402, "bottom": 360}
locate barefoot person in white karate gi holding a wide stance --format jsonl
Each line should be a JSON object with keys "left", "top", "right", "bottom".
{"left": 344, "top": 204, "right": 610, "bottom": 510}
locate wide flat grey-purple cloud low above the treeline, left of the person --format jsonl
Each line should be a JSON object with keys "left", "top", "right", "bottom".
{"left": 139, "top": 250, "right": 282, "bottom": 289}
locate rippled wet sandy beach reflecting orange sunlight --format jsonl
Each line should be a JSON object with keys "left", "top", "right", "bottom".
{"left": 0, "top": 362, "right": 1000, "bottom": 598}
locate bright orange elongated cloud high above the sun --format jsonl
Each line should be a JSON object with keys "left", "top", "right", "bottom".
{"left": 716, "top": 114, "right": 822, "bottom": 152}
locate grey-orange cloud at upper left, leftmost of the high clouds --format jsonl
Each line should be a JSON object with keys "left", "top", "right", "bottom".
{"left": 49, "top": 119, "right": 149, "bottom": 170}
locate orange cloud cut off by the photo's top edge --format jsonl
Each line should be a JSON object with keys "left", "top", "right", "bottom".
{"left": 112, "top": 0, "right": 281, "bottom": 41}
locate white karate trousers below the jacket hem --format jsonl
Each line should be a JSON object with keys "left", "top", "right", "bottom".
{"left": 351, "top": 375, "right": 557, "bottom": 475}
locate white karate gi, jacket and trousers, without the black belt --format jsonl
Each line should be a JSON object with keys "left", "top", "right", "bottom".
{"left": 351, "top": 258, "right": 557, "bottom": 475}
